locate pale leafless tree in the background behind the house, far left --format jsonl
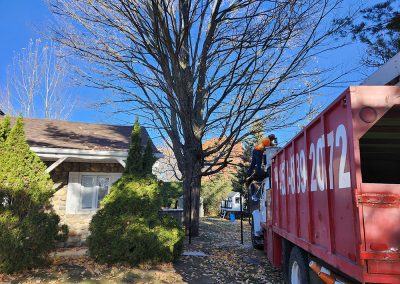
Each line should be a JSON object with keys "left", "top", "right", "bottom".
{"left": 2, "top": 39, "right": 75, "bottom": 119}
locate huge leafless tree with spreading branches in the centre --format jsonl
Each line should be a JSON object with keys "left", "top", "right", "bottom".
{"left": 49, "top": 0, "right": 348, "bottom": 235}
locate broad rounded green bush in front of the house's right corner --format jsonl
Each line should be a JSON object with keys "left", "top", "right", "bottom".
{"left": 88, "top": 175, "right": 184, "bottom": 265}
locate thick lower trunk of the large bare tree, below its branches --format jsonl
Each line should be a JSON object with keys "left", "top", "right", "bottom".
{"left": 183, "top": 146, "right": 201, "bottom": 237}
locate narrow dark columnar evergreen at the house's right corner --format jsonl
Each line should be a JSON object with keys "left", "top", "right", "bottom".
{"left": 125, "top": 118, "right": 143, "bottom": 174}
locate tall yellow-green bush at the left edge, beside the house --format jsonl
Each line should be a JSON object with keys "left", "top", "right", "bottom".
{"left": 0, "top": 118, "right": 68, "bottom": 273}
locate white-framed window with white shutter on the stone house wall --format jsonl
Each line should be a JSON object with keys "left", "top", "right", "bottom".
{"left": 66, "top": 172, "right": 121, "bottom": 214}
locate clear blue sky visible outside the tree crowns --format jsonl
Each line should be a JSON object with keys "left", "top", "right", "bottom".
{"left": 0, "top": 0, "right": 375, "bottom": 145}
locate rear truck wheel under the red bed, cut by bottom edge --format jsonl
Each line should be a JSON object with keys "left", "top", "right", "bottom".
{"left": 289, "top": 247, "right": 310, "bottom": 284}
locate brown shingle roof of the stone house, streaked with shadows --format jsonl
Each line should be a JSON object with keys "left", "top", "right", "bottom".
{"left": 2, "top": 118, "right": 158, "bottom": 152}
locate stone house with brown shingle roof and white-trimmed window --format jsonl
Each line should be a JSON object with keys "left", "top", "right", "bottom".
{"left": 2, "top": 118, "right": 160, "bottom": 245}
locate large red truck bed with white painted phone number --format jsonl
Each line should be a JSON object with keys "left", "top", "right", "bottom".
{"left": 264, "top": 86, "right": 400, "bottom": 283}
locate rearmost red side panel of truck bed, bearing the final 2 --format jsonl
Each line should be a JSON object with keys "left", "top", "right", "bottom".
{"left": 324, "top": 93, "right": 359, "bottom": 262}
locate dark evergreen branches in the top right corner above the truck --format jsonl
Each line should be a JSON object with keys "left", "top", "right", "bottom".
{"left": 351, "top": 0, "right": 400, "bottom": 67}
